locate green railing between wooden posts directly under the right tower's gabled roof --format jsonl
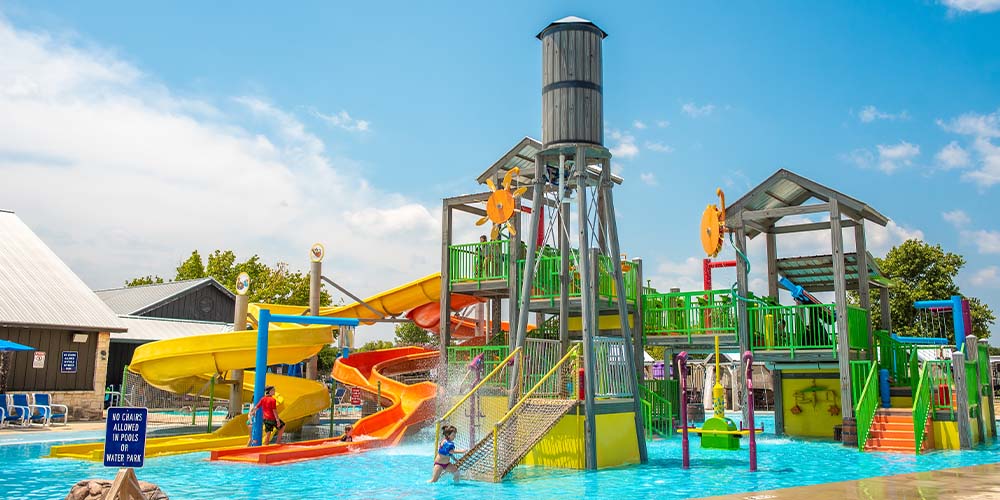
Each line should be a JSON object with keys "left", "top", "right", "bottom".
{"left": 747, "top": 304, "right": 837, "bottom": 357}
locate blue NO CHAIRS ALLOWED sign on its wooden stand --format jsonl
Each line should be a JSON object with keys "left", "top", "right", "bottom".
{"left": 104, "top": 406, "right": 148, "bottom": 500}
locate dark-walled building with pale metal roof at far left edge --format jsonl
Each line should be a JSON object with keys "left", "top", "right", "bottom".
{"left": 0, "top": 211, "right": 127, "bottom": 418}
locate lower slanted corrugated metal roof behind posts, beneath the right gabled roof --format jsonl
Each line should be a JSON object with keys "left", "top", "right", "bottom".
{"left": 778, "top": 252, "right": 890, "bottom": 292}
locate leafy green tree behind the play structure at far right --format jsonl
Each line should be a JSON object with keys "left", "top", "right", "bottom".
{"left": 851, "top": 240, "right": 996, "bottom": 340}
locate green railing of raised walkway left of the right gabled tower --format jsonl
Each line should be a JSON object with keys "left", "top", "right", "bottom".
{"left": 642, "top": 290, "right": 736, "bottom": 340}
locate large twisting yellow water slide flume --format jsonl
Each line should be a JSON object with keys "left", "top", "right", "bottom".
{"left": 49, "top": 273, "right": 441, "bottom": 460}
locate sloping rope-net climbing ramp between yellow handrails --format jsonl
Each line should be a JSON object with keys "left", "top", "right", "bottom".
{"left": 457, "top": 397, "right": 577, "bottom": 482}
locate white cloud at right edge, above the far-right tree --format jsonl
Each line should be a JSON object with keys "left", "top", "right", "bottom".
{"left": 937, "top": 110, "right": 1000, "bottom": 189}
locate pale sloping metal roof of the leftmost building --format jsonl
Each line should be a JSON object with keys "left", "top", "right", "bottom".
{"left": 0, "top": 211, "right": 125, "bottom": 332}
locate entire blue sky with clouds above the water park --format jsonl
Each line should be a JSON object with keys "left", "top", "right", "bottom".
{"left": 0, "top": 0, "right": 1000, "bottom": 342}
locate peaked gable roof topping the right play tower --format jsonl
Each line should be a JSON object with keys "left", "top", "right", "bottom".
{"left": 726, "top": 169, "right": 889, "bottom": 238}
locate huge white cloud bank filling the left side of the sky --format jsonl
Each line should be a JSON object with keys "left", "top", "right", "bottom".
{"left": 0, "top": 14, "right": 440, "bottom": 335}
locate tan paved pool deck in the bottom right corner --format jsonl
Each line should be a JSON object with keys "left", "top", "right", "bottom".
{"left": 705, "top": 463, "right": 1000, "bottom": 500}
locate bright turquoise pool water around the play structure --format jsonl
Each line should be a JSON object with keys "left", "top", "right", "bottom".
{"left": 7, "top": 420, "right": 1000, "bottom": 500}
